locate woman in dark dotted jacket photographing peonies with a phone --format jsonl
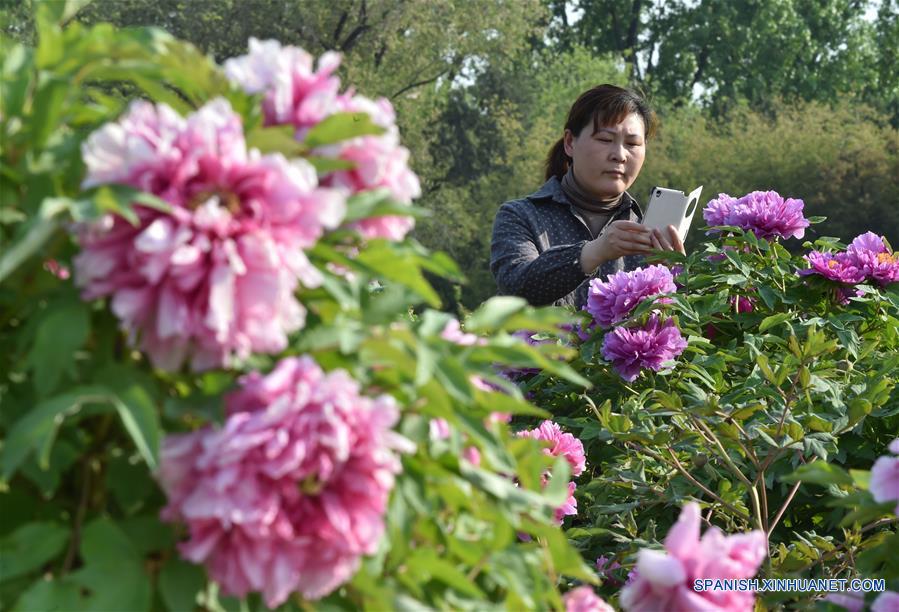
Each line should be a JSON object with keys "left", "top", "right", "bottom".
{"left": 490, "top": 85, "right": 684, "bottom": 309}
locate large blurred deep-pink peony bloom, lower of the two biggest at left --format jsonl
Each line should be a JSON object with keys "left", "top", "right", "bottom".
{"left": 158, "top": 357, "right": 410, "bottom": 608}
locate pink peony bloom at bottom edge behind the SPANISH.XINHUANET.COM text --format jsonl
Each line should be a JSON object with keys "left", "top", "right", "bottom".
{"left": 620, "top": 503, "right": 767, "bottom": 612}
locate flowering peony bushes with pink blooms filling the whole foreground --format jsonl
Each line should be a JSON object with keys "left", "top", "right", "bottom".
{"left": 0, "top": 2, "right": 899, "bottom": 612}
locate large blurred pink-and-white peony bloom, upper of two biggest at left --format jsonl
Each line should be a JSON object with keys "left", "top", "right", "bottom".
{"left": 74, "top": 99, "right": 345, "bottom": 370}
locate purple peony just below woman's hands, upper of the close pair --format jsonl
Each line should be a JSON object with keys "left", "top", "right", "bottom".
{"left": 585, "top": 265, "right": 677, "bottom": 327}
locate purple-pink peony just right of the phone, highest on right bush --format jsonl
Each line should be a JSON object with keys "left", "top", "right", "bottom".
{"left": 702, "top": 191, "right": 809, "bottom": 238}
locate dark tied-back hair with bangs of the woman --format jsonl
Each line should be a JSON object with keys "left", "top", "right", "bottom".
{"left": 544, "top": 84, "right": 656, "bottom": 180}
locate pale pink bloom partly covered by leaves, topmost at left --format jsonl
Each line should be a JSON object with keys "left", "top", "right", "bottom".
{"left": 225, "top": 39, "right": 421, "bottom": 240}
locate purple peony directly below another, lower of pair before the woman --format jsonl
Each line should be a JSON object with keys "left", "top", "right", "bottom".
{"left": 602, "top": 314, "right": 687, "bottom": 382}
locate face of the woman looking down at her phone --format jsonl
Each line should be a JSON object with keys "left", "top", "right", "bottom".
{"left": 565, "top": 113, "right": 646, "bottom": 200}
